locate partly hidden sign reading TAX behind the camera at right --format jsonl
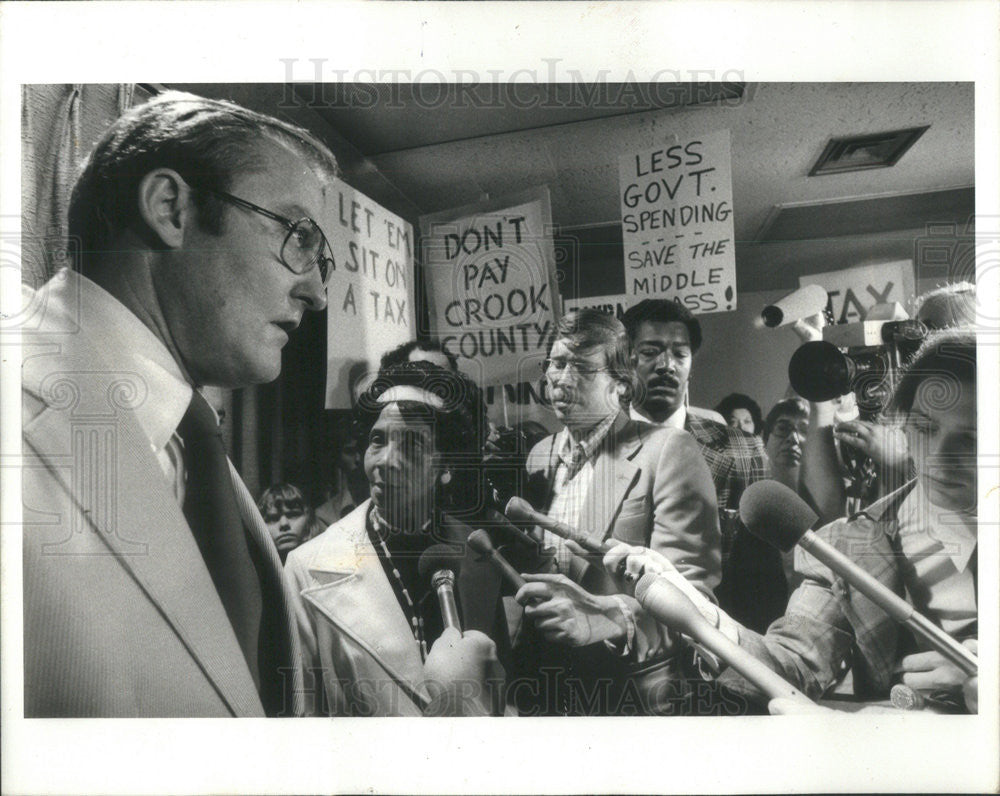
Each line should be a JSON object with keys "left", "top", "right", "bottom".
{"left": 799, "top": 260, "right": 915, "bottom": 323}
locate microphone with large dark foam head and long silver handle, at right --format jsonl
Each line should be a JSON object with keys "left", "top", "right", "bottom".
{"left": 740, "top": 481, "right": 979, "bottom": 675}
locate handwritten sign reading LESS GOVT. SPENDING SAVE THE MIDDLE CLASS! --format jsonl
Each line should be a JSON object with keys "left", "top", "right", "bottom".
{"left": 618, "top": 130, "right": 736, "bottom": 313}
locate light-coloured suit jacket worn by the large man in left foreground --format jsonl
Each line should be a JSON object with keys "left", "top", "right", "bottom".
{"left": 22, "top": 282, "right": 301, "bottom": 717}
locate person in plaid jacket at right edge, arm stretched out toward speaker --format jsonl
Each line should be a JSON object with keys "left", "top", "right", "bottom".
{"left": 605, "top": 330, "right": 978, "bottom": 711}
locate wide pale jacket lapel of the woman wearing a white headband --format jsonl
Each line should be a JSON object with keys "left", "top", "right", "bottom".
{"left": 292, "top": 501, "right": 428, "bottom": 704}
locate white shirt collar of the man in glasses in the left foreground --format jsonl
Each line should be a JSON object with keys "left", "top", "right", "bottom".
{"left": 68, "top": 271, "right": 192, "bottom": 453}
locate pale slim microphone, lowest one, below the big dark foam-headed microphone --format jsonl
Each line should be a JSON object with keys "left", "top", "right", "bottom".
{"left": 635, "top": 572, "right": 812, "bottom": 702}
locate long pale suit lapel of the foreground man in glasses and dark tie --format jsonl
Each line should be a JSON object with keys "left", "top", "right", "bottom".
{"left": 24, "top": 407, "right": 263, "bottom": 716}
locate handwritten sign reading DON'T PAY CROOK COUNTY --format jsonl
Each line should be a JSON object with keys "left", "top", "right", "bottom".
{"left": 421, "top": 191, "right": 558, "bottom": 384}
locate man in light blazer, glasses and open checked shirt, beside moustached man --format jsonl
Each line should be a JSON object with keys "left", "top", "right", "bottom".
{"left": 516, "top": 310, "right": 720, "bottom": 713}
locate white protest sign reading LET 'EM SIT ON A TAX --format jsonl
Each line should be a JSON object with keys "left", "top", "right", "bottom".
{"left": 322, "top": 181, "right": 416, "bottom": 409}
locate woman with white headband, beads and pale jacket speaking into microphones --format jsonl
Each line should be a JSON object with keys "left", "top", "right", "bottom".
{"left": 286, "top": 362, "right": 505, "bottom": 715}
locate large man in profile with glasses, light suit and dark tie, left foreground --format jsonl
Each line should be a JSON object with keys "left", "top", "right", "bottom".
{"left": 23, "top": 93, "right": 352, "bottom": 717}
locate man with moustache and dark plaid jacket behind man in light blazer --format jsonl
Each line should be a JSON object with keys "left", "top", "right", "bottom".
{"left": 622, "top": 299, "right": 788, "bottom": 631}
